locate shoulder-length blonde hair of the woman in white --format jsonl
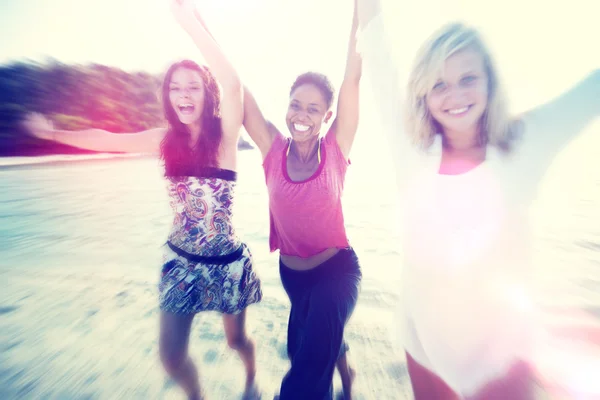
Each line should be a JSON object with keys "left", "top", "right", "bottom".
{"left": 405, "top": 23, "right": 516, "bottom": 152}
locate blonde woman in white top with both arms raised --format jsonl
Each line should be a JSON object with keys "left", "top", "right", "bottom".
{"left": 359, "top": 0, "right": 600, "bottom": 400}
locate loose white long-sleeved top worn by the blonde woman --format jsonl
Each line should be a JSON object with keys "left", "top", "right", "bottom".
{"left": 359, "top": 11, "right": 600, "bottom": 396}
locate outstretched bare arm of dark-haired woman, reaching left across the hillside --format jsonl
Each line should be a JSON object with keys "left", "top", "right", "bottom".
{"left": 24, "top": 114, "right": 167, "bottom": 153}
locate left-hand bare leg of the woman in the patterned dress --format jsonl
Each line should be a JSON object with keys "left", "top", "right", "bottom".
{"left": 159, "top": 311, "right": 203, "bottom": 400}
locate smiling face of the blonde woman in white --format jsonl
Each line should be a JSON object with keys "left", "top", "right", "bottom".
{"left": 426, "top": 49, "right": 488, "bottom": 145}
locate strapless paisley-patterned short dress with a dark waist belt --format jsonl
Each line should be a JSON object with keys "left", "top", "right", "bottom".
{"left": 159, "top": 168, "right": 262, "bottom": 314}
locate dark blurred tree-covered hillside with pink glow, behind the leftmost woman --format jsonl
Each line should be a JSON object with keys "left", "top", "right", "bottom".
{"left": 0, "top": 61, "right": 252, "bottom": 156}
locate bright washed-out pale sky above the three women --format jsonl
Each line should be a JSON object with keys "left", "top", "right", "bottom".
{"left": 0, "top": 0, "right": 600, "bottom": 119}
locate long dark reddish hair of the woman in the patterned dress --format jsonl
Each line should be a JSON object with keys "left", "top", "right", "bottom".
{"left": 160, "top": 60, "right": 223, "bottom": 176}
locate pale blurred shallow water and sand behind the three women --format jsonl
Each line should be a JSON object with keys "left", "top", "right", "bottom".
{"left": 0, "top": 135, "right": 600, "bottom": 400}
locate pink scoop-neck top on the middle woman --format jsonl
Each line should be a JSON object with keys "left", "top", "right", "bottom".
{"left": 263, "top": 130, "right": 350, "bottom": 258}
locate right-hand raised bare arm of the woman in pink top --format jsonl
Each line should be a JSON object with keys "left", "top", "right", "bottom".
{"left": 334, "top": 0, "right": 362, "bottom": 158}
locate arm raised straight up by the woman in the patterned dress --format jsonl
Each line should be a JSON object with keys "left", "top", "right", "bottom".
{"left": 169, "top": 0, "right": 244, "bottom": 145}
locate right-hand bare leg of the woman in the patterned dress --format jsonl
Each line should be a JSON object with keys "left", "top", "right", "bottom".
{"left": 223, "top": 310, "right": 256, "bottom": 392}
